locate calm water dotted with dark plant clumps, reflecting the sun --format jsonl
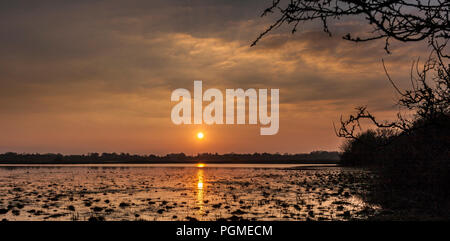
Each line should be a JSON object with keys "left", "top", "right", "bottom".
{"left": 0, "top": 164, "right": 379, "bottom": 220}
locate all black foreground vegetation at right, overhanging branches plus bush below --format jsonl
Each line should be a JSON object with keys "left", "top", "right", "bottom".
{"left": 253, "top": 0, "right": 450, "bottom": 219}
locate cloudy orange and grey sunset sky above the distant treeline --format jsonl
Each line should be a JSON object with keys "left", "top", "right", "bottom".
{"left": 0, "top": 0, "right": 426, "bottom": 154}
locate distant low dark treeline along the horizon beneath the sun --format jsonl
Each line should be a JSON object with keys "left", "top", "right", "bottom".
{"left": 0, "top": 151, "right": 339, "bottom": 164}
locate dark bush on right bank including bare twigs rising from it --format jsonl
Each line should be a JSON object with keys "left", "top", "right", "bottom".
{"left": 337, "top": 38, "right": 450, "bottom": 219}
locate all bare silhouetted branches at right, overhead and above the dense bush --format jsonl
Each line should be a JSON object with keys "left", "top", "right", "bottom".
{"left": 252, "top": 0, "right": 450, "bottom": 143}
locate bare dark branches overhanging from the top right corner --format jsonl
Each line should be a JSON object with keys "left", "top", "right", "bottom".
{"left": 251, "top": 0, "right": 450, "bottom": 52}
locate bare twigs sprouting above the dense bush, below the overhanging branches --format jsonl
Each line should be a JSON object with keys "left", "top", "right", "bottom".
{"left": 336, "top": 51, "right": 450, "bottom": 139}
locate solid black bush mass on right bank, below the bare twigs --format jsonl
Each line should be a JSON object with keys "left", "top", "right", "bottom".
{"left": 341, "top": 115, "right": 450, "bottom": 216}
